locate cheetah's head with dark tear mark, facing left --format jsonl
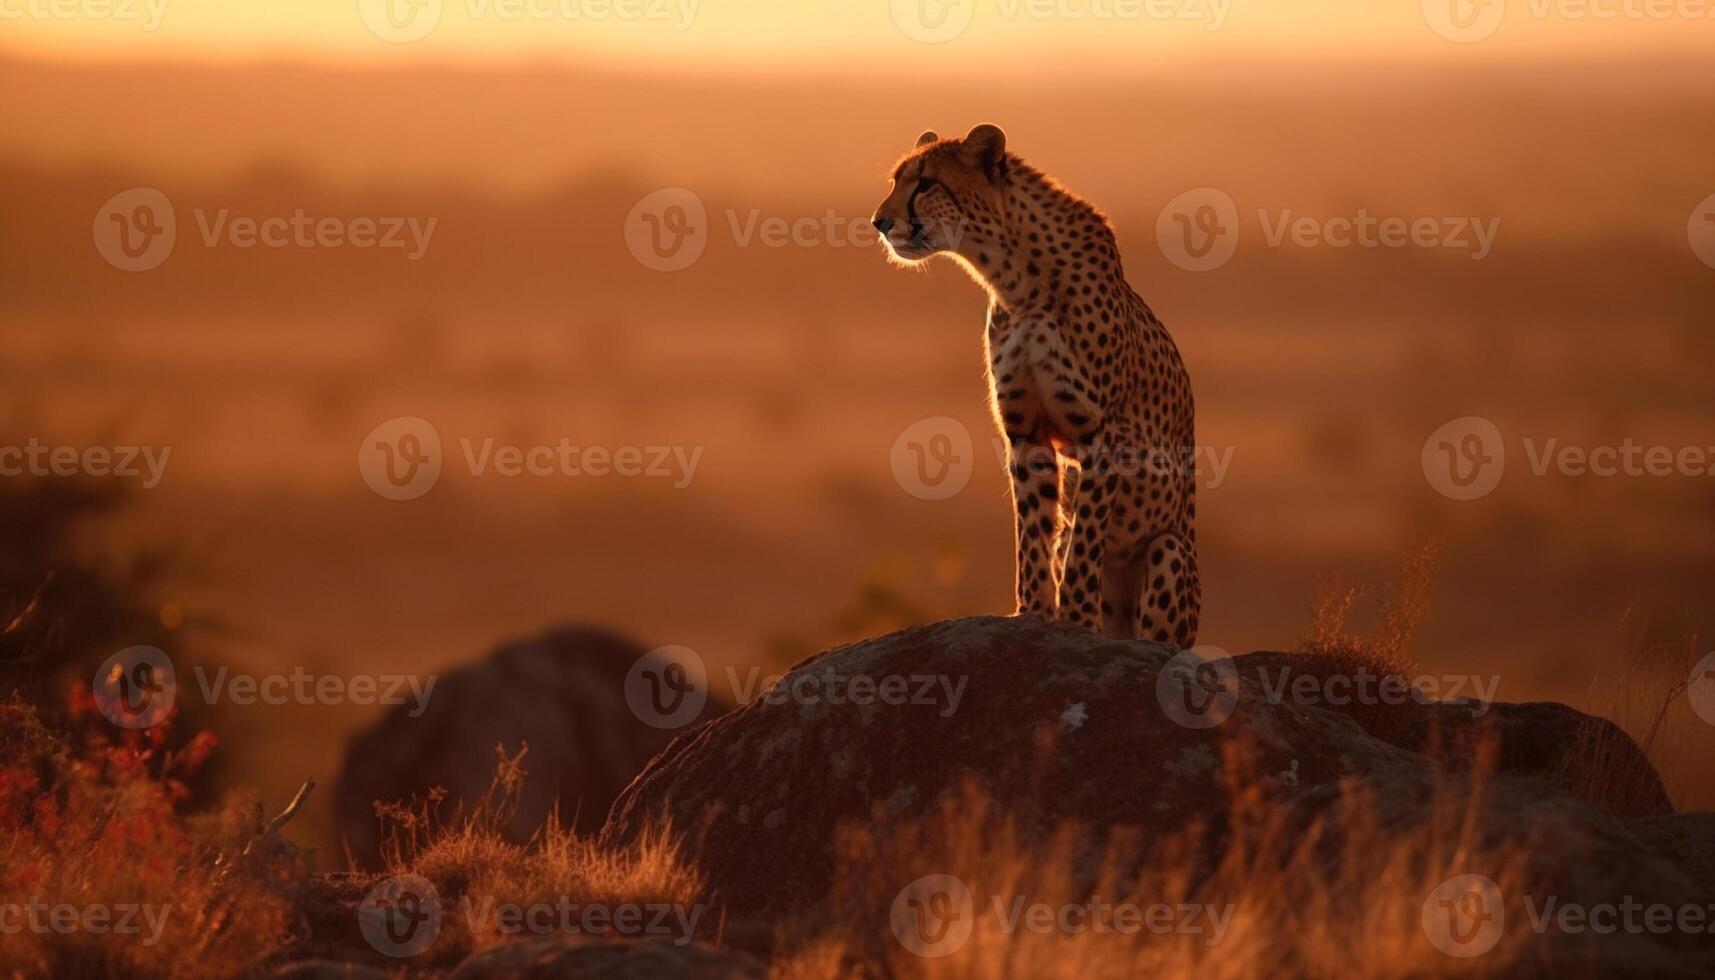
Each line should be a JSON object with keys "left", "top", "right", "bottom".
{"left": 873, "top": 124, "right": 1007, "bottom": 264}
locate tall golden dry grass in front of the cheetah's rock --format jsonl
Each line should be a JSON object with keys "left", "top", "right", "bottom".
{"left": 773, "top": 758, "right": 1523, "bottom": 980}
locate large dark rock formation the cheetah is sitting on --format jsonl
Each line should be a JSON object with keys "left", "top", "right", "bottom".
{"left": 604, "top": 618, "right": 1715, "bottom": 966}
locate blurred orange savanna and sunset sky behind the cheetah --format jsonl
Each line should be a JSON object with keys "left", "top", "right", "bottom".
{"left": 0, "top": 0, "right": 1715, "bottom": 865}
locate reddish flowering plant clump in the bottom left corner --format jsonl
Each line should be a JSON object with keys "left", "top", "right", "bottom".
{"left": 0, "top": 685, "right": 309, "bottom": 977}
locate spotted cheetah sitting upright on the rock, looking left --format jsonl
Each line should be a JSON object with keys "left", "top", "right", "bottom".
{"left": 873, "top": 124, "right": 1202, "bottom": 647}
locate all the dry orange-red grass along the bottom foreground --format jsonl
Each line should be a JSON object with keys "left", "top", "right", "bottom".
{"left": 0, "top": 705, "right": 1632, "bottom": 980}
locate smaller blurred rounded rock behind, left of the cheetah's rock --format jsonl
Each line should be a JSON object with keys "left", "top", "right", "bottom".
{"left": 334, "top": 628, "right": 724, "bottom": 867}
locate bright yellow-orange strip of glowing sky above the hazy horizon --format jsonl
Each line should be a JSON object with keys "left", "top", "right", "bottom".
{"left": 0, "top": 0, "right": 1715, "bottom": 66}
